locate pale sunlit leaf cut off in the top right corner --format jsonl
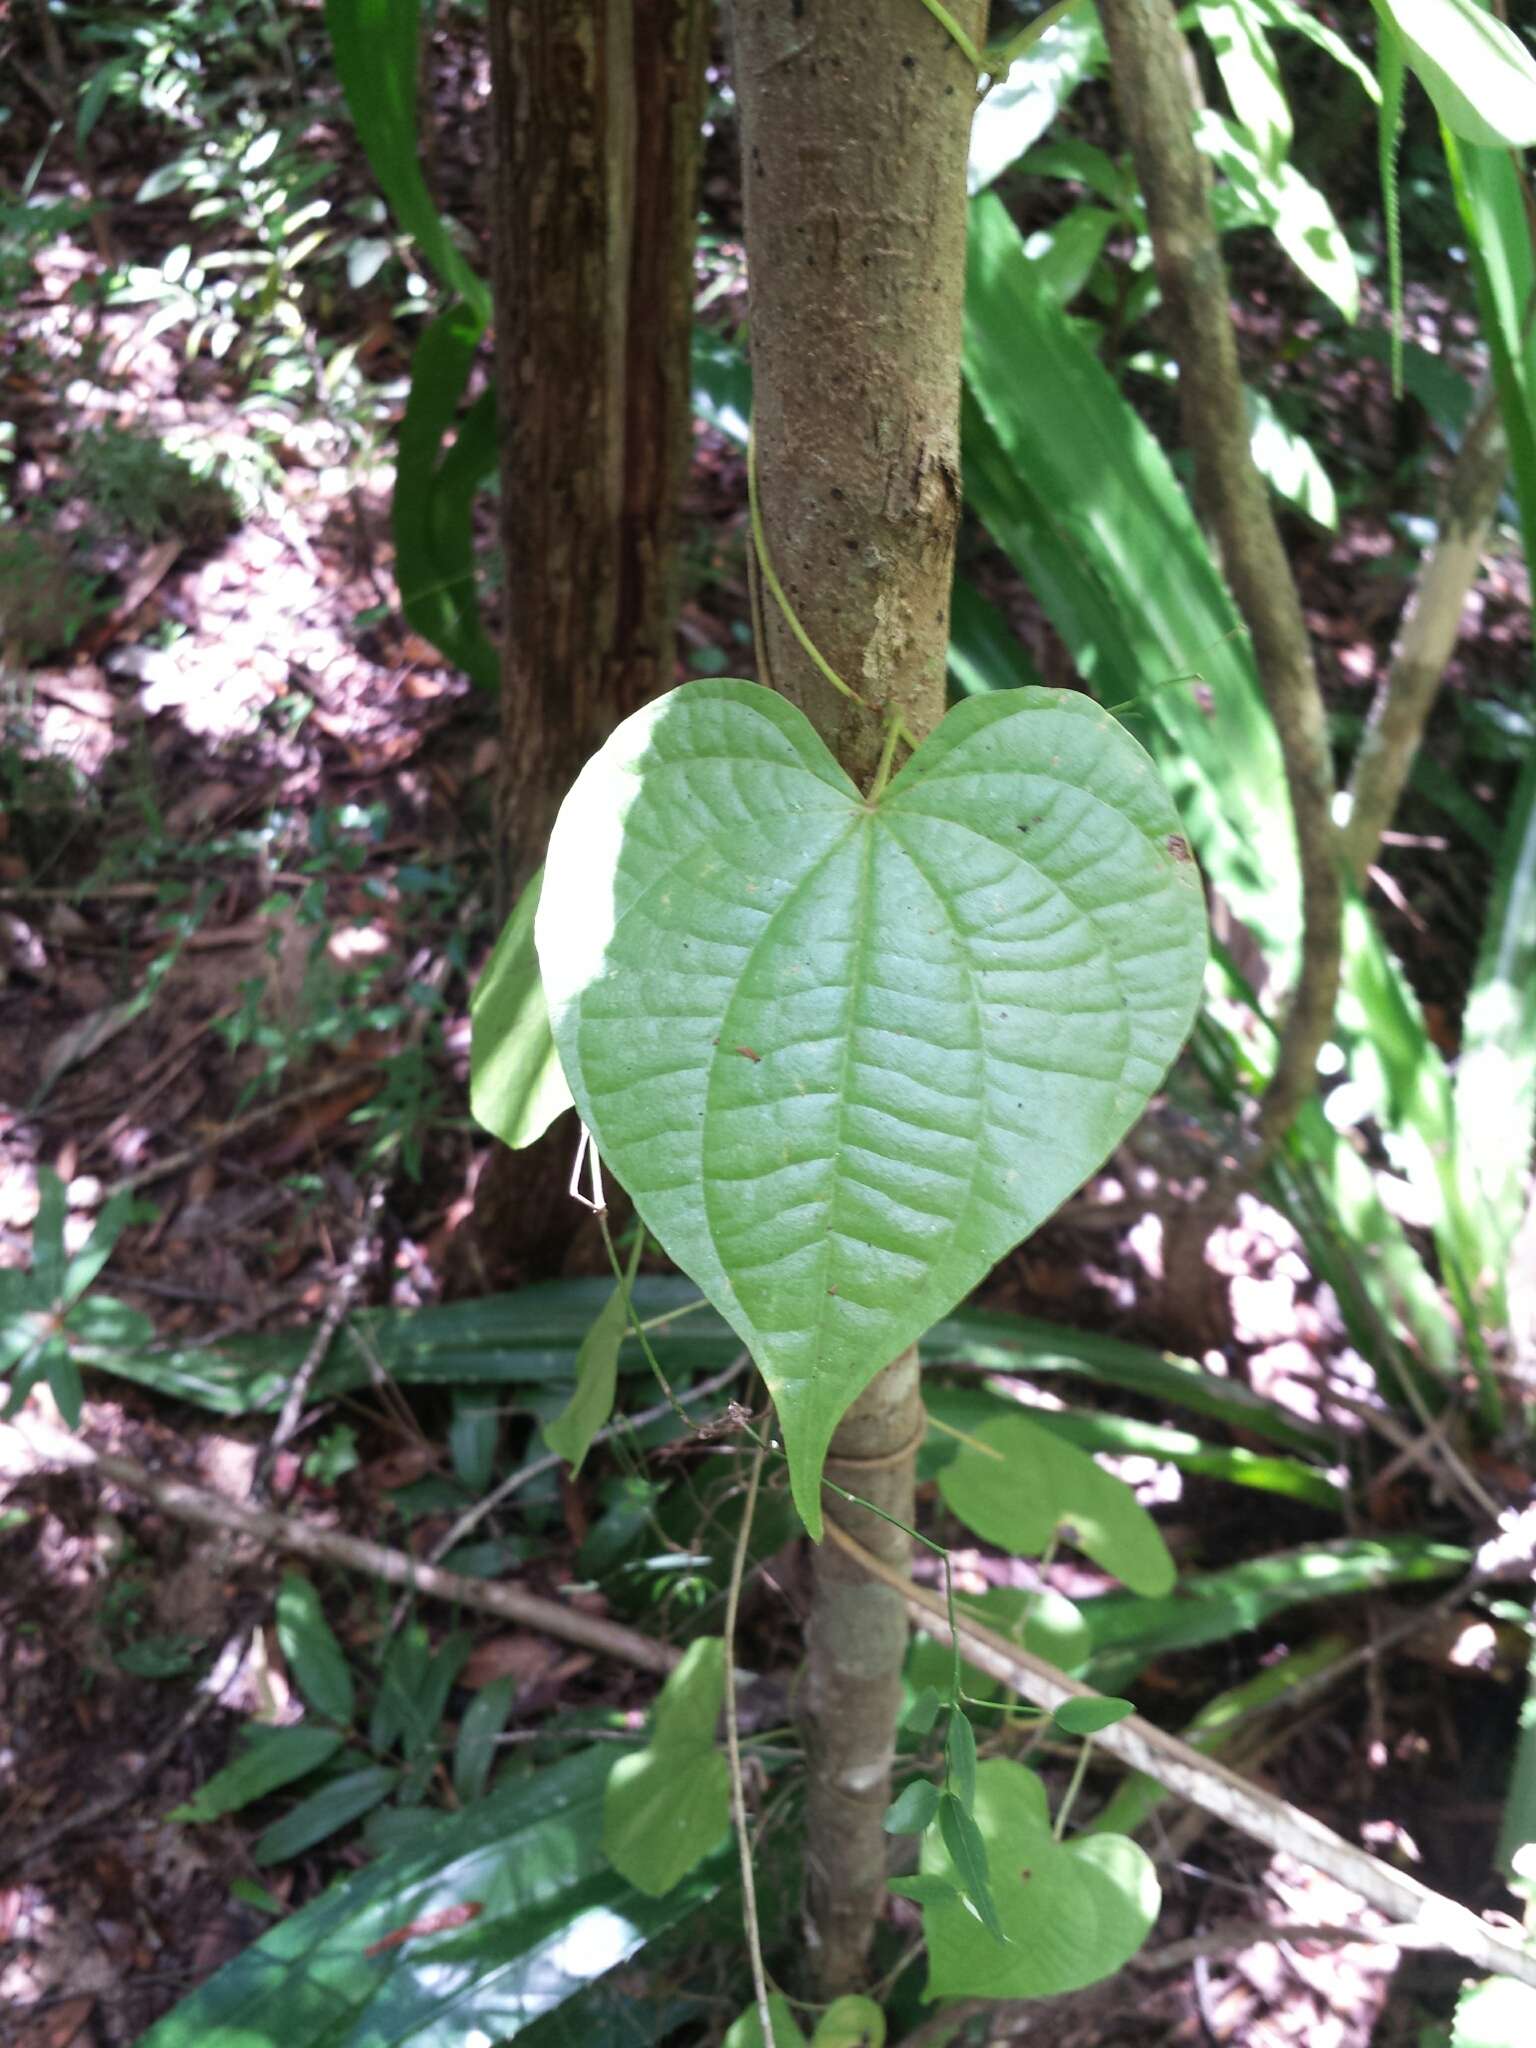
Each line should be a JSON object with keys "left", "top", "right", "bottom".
{"left": 1372, "top": 0, "right": 1536, "bottom": 150}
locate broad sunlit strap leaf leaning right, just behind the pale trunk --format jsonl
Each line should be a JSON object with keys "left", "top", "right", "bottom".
{"left": 963, "top": 195, "right": 1300, "bottom": 983}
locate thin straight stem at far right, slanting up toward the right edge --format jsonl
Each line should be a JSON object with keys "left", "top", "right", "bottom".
{"left": 1343, "top": 391, "right": 1509, "bottom": 883}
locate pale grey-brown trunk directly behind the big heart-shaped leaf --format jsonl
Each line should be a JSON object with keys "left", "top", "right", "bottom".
{"left": 735, "top": 0, "right": 985, "bottom": 1997}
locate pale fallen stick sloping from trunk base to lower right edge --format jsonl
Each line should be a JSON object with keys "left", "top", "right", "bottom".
{"left": 827, "top": 1520, "right": 1536, "bottom": 1987}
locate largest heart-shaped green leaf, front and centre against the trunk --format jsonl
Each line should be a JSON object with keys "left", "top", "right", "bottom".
{"left": 537, "top": 678, "right": 1206, "bottom": 1534}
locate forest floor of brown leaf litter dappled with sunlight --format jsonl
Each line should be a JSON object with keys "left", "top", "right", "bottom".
{"left": 0, "top": 8, "right": 1530, "bottom": 2048}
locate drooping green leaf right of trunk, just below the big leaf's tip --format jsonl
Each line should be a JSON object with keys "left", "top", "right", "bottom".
{"left": 938, "top": 1415, "right": 1176, "bottom": 1599}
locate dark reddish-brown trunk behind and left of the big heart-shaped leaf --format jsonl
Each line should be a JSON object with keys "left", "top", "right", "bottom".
{"left": 473, "top": 0, "right": 709, "bottom": 1284}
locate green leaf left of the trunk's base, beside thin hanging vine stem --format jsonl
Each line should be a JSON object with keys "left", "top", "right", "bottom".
{"left": 602, "top": 1636, "right": 731, "bottom": 1898}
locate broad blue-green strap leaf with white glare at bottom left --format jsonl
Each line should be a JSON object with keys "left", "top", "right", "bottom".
{"left": 139, "top": 1747, "right": 713, "bottom": 2048}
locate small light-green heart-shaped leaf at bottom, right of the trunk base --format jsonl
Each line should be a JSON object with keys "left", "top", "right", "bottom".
{"left": 924, "top": 1759, "right": 1159, "bottom": 1999}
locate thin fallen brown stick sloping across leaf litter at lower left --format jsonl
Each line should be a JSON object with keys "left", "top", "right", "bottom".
{"left": 0, "top": 1413, "right": 678, "bottom": 1675}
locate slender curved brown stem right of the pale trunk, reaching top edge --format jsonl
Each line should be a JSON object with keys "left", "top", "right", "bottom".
{"left": 1100, "top": 0, "right": 1343, "bottom": 1171}
